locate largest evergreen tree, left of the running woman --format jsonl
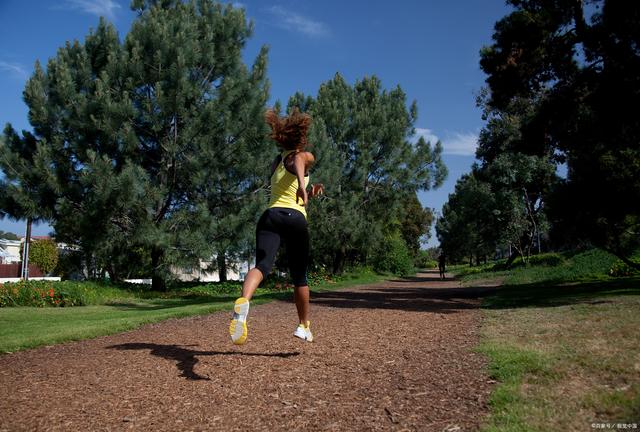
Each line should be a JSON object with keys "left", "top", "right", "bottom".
{"left": 3, "top": 0, "right": 268, "bottom": 289}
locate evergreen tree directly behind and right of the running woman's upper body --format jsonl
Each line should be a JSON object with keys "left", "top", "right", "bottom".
{"left": 289, "top": 74, "right": 447, "bottom": 272}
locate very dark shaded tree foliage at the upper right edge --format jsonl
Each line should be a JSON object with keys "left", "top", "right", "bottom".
{"left": 479, "top": 0, "right": 640, "bottom": 267}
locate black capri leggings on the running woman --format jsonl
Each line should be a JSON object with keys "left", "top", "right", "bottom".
{"left": 256, "top": 207, "right": 309, "bottom": 286}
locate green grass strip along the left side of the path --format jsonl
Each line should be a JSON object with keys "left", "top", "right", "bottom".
{"left": 0, "top": 271, "right": 385, "bottom": 353}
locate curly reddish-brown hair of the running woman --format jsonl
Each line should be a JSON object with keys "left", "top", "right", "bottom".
{"left": 264, "top": 107, "right": 311, "bottom": 150}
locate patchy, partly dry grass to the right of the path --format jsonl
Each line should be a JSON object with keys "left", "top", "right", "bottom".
{"left": 466, "top": 252, "right": 640, "bottom": 431}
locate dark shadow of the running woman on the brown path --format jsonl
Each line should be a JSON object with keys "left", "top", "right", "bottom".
{"left": 107, "top": 342, "right": 300, "bottom": 381}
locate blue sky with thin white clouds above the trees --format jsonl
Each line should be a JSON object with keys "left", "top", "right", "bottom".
{"left": 0, "top": 0, "right": 509, "bottom": 245}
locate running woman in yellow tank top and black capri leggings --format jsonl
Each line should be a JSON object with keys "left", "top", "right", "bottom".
{"left": 229, "top": 108, "right": 324, "bottom": 345}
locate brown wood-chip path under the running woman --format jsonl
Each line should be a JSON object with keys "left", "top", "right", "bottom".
{"left": 0, "top": 272, "right": 500, "bottom": 432}
